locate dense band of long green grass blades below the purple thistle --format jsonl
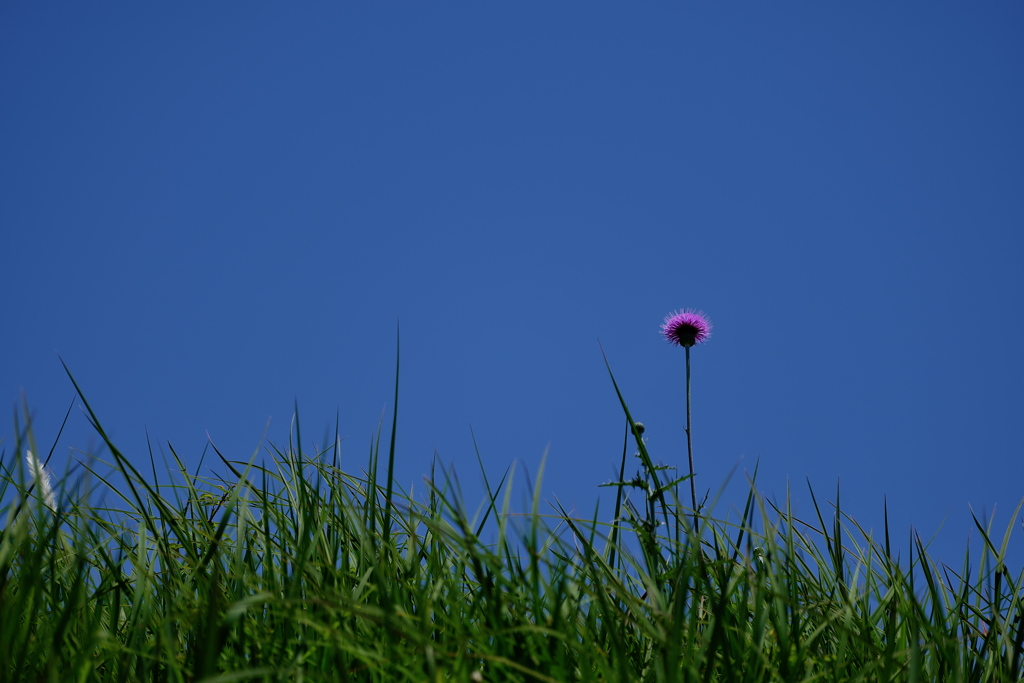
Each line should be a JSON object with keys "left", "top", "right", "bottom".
{"left": 0, "top": 366, "right": 1024, "bottom": 683}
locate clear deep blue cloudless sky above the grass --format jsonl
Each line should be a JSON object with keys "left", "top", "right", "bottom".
{"left": 0, "top": 2, "right": 1024, "bottom": 564}
